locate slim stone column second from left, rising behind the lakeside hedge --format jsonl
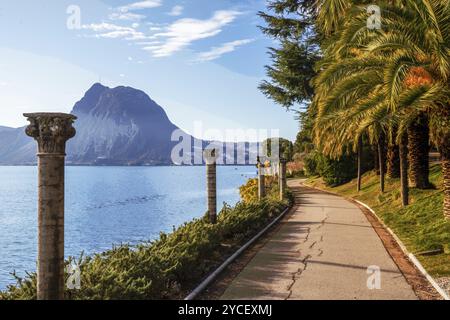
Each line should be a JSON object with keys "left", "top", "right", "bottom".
{"left": 204, "top": 149, "right": 217, "bottom": 223}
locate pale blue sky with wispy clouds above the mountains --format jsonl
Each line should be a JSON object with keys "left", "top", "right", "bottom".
{"left": 0, "top": 0, "right": 298, "bottom": 140}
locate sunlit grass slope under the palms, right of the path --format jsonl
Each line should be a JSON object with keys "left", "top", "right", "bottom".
{"left": 306, "top": 165, "right": 450, "bottom": 278}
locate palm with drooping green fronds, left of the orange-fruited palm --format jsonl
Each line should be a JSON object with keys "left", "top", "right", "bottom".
{"left": 313, "top": 4, "right": 392, "bottom": 192}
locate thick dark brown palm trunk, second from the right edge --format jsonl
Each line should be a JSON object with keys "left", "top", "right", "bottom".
{"left": 408, "top": 113, "right": 431, "bottom": 189}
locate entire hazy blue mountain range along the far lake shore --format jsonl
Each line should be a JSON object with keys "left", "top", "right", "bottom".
{"left": 0, "top": 83, "right": 256, "bottom": 165}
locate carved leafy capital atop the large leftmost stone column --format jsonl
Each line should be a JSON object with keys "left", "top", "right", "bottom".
{"left": 24, "top": 113, "right": 77, "bottom": 155}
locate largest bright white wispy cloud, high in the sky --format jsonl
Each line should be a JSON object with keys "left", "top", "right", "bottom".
{"left": 144, "top": 10, "right": 241, "bottom": 57}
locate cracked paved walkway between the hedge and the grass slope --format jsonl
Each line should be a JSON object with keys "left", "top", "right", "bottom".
{"left": 221, "top": 180, "right": 417, "bottom": 300}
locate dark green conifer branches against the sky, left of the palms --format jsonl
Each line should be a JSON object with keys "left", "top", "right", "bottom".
{"left": 259, "top": 0, "right": 319, "bottom": 108}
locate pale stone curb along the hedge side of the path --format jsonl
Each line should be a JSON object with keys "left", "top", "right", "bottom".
{"left": 184, "top": 205, "right": 292, "bottom": 300}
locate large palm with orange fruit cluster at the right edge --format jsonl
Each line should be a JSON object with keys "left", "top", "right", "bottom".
{"left": 368, "top": 0, "right": 450, "bottom": 217}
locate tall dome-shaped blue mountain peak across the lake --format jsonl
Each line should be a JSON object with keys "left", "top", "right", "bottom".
{"left": 67, "top": 83, "right": 183, "bottom": 165}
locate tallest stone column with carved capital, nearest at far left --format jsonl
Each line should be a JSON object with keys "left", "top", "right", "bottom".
{"left": 24, "top": 113, "right": 76, "bottom": 300}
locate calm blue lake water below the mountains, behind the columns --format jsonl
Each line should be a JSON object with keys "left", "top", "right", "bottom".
{"left": 0, "top": 166, "right": 256, "bottom": 290}
